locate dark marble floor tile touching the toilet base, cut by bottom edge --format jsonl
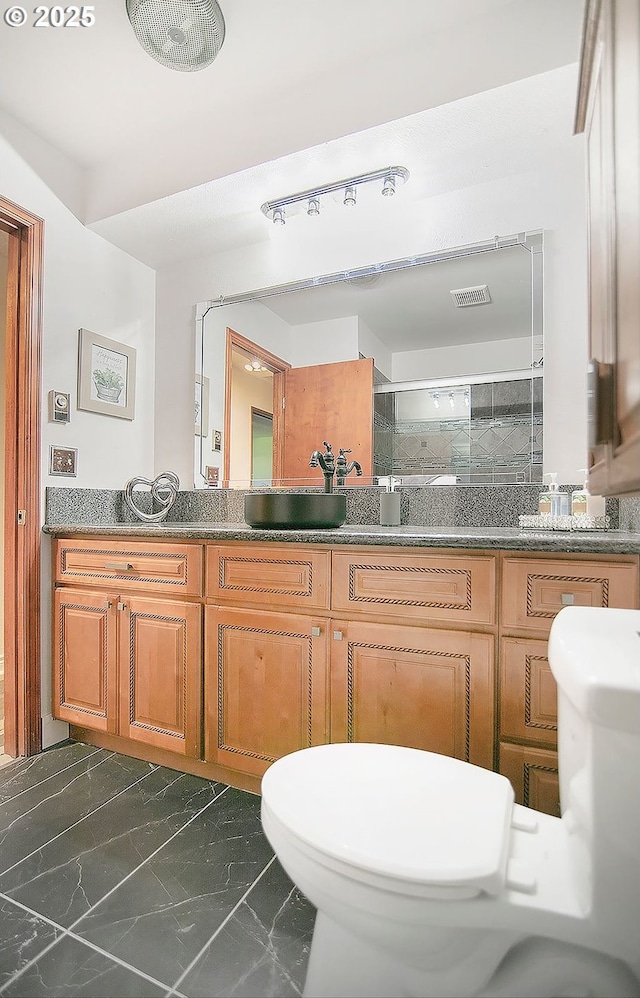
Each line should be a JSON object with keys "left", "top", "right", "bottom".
{"left": 178, "top": 860, "right": 315, "bottom": 998}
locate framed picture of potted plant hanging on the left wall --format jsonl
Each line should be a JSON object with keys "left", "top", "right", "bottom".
{"left": 78, "top": 329, "right": 136, "bottom": 419}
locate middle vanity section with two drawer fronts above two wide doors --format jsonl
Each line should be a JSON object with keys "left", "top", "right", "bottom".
{"left": 205, "top": 544, "right": 495, "bottom": 774}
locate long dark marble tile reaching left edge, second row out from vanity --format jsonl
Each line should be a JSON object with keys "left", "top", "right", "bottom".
{"left": 0, "top": 767, "right": 224, "bottom": 927}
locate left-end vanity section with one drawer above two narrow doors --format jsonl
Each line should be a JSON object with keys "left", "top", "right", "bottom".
{"left": 52, "top": 540, "right": 202, "bottom": 758}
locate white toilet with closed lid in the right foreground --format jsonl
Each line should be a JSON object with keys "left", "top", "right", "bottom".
{"left": 262, "top": 607, "right": 640, "bottom": 998}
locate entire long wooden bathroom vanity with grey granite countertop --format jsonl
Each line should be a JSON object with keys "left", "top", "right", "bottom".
{"left": 45, "top": 524, "right": 640, "bottom": 813}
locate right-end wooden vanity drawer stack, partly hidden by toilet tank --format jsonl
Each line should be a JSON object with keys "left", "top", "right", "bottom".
{"left": 498, "top": 553, "right": 639, "bottom": 815}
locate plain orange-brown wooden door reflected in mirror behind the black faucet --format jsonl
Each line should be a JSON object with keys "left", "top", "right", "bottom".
{"left": 282, "top": 357, "right": 373, "bottom": 486}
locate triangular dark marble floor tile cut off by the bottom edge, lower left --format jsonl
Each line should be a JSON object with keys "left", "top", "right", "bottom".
{"left": 2, "top": 936, "right": 167, "bottom": 998}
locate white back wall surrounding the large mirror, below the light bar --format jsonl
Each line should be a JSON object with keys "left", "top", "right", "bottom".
{"left": 156, "top": 136, "right": 587, "bottom": 482}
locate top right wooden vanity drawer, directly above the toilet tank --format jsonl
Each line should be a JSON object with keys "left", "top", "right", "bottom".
{"left": 502, "top": 558, "right": 638, "bottom": 634}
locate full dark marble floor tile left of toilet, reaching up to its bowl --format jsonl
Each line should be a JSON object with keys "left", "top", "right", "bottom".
{"left": 75, "top": 788, "right": 273, "bottom": 984}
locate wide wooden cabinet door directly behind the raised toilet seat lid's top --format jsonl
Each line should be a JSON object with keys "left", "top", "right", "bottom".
{"left": 331, "top": 621, "right": 494, "bottom": 769}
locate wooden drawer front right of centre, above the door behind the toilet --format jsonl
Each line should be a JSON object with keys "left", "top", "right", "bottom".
{"left": 332, "top": 549, "right": 495, "bottom": 624}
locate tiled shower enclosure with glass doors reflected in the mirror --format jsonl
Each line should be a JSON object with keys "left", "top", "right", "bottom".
{"left": 374, "top": 372, "right": 542, "bottom": 484}
